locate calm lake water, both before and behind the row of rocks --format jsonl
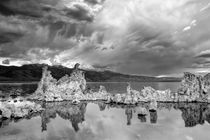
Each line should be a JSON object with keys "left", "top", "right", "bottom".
{"left": 0, "top": 83, "right": 210, "bottom": 140}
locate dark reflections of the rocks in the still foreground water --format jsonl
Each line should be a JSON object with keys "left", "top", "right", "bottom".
{"left": 0, "top": 102, "right": 210, "bottom": 132}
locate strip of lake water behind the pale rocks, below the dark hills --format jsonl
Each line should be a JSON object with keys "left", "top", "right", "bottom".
{"left": 0, "top": 82, "right": 180, "bottom": 96}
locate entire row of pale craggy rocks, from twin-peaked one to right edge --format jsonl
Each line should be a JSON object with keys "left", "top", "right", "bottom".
{"left": 30, "top": 64, "right": 210, "bottom": 105}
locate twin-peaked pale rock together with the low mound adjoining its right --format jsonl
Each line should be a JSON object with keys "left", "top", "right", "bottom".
{"left": 29, "top": 64, "right": 113, "bottom": 103}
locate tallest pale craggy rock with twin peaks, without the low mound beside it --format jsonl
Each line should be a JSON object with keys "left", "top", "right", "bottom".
{"left": 30, "top": 64, "right": 86, "bottom": 101}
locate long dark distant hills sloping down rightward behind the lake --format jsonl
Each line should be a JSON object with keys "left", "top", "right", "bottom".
{"left": 0, "top": 64, "right": 181, "bottom": 82}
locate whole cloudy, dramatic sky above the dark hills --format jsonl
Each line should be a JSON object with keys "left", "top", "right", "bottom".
{"left": 0, "top": 0, "right": 210, "bottom": 76}
